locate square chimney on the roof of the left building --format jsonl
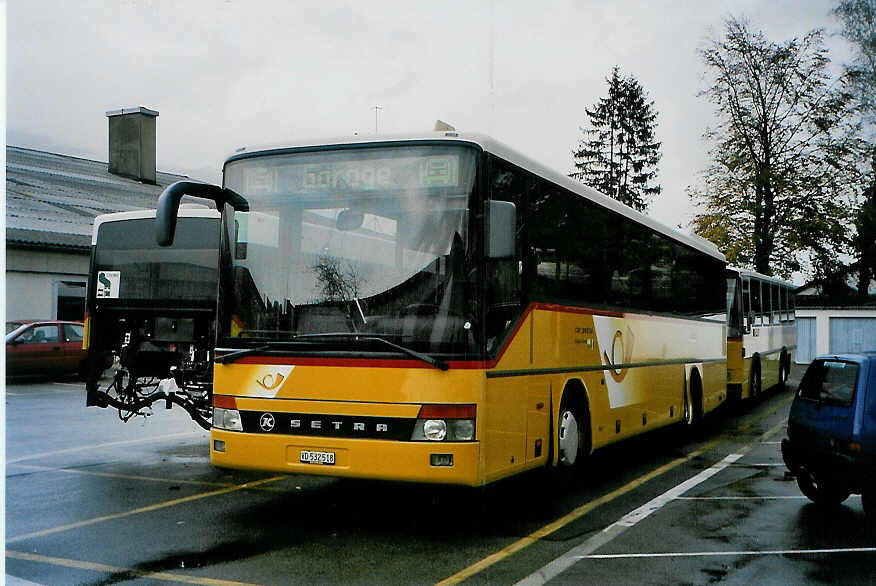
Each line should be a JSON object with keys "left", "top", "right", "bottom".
{"left": 106, "top": 106, "right": 158, "bottom": 184}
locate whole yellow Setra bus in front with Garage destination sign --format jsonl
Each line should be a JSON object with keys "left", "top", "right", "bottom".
{"left": 157, "top": 132, "right": 727, "bottom": 486}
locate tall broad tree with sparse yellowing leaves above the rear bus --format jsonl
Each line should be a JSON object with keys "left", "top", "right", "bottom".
{"left": 688, "top": 18, "right": 855, "bottom": 277}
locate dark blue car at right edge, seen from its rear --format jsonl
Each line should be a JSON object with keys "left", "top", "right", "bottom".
{"left": 782, "top": 352, "right": 876, "bottom": 515}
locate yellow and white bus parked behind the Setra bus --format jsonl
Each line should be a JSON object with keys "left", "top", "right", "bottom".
{"left": 727, "top": 267, "right": 797, "bottom": 399}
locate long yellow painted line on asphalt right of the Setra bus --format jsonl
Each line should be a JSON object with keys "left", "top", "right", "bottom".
{"left": 436, "top": 396, "right": 794, "bottom": 586}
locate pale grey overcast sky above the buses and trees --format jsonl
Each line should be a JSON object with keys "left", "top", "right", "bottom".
{"left": 7, "top": 0, "right": 848, "bottom": 232}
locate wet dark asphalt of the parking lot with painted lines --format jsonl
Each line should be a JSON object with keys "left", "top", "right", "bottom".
{"left": 6, "top": 368, "right": 876, "bottom": 584}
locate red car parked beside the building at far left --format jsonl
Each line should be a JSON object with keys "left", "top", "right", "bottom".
{"left": 6, "top": 321, "right": 94, "bottom": 376}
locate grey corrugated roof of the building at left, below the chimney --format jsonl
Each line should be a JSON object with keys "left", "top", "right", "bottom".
{"left": 6, "top": 145, "right": 186, "bottom": 249}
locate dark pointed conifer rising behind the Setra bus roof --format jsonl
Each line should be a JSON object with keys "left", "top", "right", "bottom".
{"left": 569, "top": 66, "right": 661, "bottom": 212}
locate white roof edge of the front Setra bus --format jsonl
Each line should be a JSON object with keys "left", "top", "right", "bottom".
{"left": 226, "top": 131, "right": 725, "bottom": 261}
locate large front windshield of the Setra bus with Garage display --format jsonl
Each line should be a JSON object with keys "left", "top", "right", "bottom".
{"left": 220, "top": 144, "right": 478, "bottom": 356}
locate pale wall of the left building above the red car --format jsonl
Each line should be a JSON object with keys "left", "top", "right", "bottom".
{"left": 6, "top": 248, "right": 89, "bottom": 320}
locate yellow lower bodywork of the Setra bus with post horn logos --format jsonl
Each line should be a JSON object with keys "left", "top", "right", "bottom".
{"left": 211, "top": 304, "right": 727, "bottom": 486}
